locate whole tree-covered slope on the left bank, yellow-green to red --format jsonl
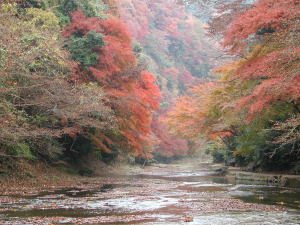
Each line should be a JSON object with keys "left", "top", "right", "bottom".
{"left": 0, "top": 0, "right": 161, "bottom": 172}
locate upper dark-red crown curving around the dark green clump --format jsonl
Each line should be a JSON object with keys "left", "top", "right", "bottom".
{"left": 64, "top": 10, "right": 136, "bottom": 82}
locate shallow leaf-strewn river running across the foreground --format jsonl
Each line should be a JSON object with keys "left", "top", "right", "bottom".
{"left": 0, "top": 167, "right": 300, "bottom": 225}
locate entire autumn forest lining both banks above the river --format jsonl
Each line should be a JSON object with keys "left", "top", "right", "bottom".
{"left": 0, "top": 0, "right": 300, "bottom": 173}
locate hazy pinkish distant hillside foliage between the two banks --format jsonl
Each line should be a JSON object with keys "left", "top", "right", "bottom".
{"left": 119, "top": 0, "right": 216, "bottom": 157}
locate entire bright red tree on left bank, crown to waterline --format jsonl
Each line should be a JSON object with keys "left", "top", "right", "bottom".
{"left": 64, "top": 10, "right": 160, "bottom": 157}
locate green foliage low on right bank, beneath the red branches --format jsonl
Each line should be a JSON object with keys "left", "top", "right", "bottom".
{"left": 208, "top": 102, "right": 298, "bottom": 170}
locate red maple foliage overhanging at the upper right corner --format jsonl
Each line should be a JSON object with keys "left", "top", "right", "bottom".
{"left": 220, "top": 0, "right": 300, "bottom": 122}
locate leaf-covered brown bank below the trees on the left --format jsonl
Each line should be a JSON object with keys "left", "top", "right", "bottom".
{"left": 0, "top": 159, "right": 119, "bottom": 196}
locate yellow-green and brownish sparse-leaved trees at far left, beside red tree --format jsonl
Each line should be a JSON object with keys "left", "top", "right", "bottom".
{"left": 0, "top": 4, "right": 115, "bottom": 160}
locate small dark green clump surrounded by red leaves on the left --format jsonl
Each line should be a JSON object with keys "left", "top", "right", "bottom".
{"left": 67, "top": 31, "right": 105, "bottom": 67}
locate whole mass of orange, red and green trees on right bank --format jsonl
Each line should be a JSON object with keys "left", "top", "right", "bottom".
{"left": 165, "top": 0, "right": 300, "bottom": 168}
